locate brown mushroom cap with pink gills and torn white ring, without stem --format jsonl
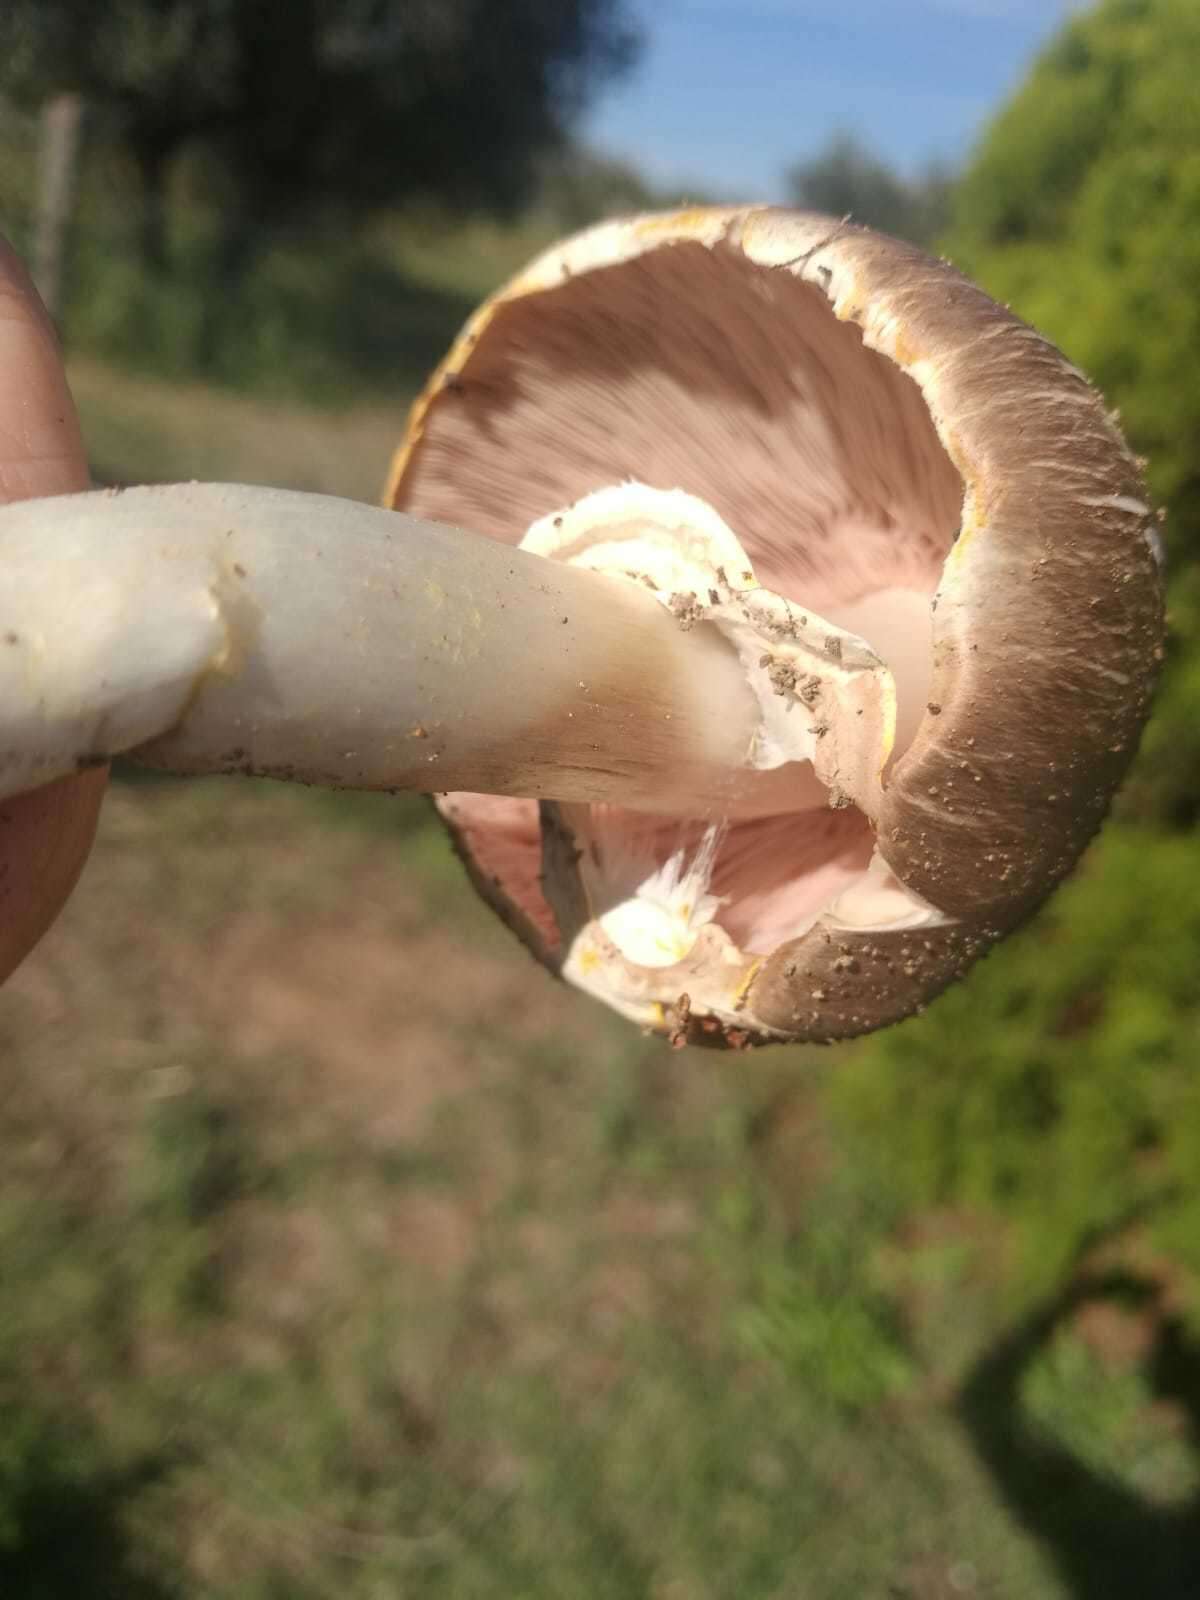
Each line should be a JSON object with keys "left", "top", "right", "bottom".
{"left": 386, "top": 206, "right": 1163, "bottom": 1046}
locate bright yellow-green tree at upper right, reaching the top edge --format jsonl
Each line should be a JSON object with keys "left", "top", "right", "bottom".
{"left": 947, "top": 0, "right": 1200, "bottom": 826}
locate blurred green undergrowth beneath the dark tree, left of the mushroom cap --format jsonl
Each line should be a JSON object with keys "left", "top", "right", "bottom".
{"left": 0, "top": 92, "right": 668, "bottom": 403}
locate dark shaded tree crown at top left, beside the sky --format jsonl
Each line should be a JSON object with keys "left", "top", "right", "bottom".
{"left": 0, "top": 0, "right": 637, "bottom": 267}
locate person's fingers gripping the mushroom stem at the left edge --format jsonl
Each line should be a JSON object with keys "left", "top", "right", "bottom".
{"left": 0, "top": 240, "right": 107, "bottom": 982}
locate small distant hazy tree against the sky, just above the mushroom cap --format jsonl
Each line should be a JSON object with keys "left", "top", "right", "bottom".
{"left": 787, "top": 133, "right": 950, "bottom": 245}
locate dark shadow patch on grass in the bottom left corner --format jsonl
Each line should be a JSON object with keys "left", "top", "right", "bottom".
{"left": 0, "top": 1424, "right": 176, "bottom": 1600}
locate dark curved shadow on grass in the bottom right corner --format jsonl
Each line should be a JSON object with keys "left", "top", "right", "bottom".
{"left": 958, "top": 1270, "right": 1200, "bottom": 1600}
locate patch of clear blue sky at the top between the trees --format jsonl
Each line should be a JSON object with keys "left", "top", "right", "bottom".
{"left": 584, "top": 0, "right": 1077, "bottom": 200}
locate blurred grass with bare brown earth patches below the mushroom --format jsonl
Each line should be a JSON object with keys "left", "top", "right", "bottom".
{"left": 0, "top": 781, "right": 1194, "bottom": 1600}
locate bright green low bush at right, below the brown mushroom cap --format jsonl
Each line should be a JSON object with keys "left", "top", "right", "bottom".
{"left": 832, "top": 824, "right": 1200, "bottom": 1328}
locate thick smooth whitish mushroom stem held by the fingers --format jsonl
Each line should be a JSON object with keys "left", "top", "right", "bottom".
{"left": 0, "top": 485, "right": 824, "bottom": 816}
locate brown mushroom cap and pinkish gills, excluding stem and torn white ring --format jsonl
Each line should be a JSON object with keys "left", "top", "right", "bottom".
{"left": 386, "top": 206, "right": 1163, "bottom": 1045}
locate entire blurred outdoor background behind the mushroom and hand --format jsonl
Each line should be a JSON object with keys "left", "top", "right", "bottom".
{"left": 0, "top": 0, "right": 1200, "bottom": 1600}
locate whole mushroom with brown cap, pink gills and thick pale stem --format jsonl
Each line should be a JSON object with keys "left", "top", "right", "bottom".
{"left": 0, "top": 208, "right": 1163, "bottom": 1046}
